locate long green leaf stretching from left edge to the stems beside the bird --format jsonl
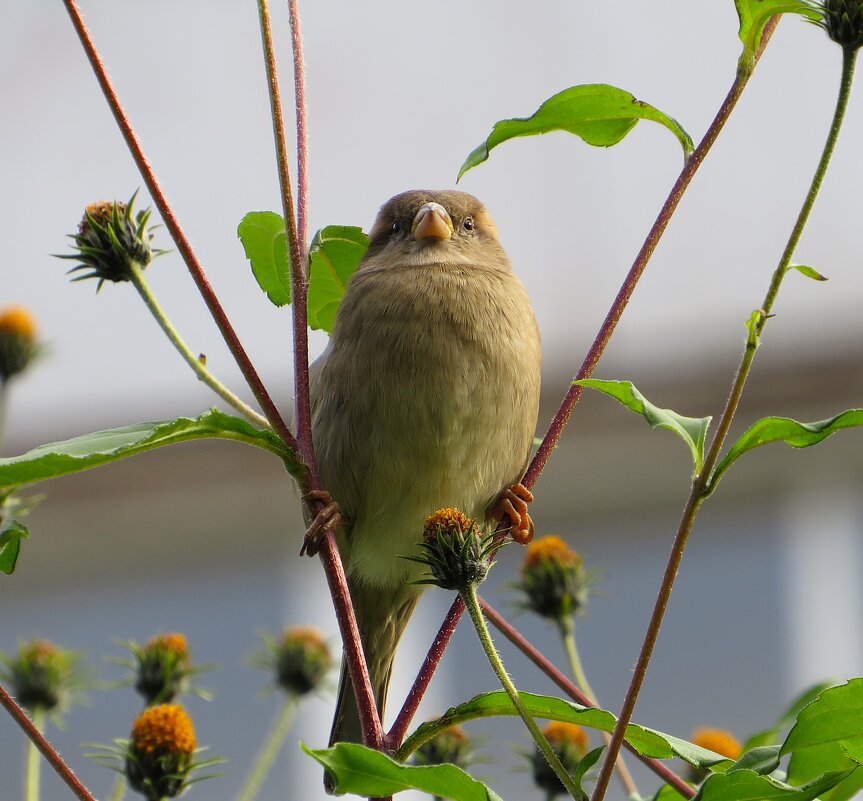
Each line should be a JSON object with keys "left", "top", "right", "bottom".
{"left": 0, "top": 408, "right": 302, "bottom": 487}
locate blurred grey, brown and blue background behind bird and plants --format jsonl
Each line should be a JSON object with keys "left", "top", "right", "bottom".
{"left": 0, "top": 0, "right": 863, "bottom": 801}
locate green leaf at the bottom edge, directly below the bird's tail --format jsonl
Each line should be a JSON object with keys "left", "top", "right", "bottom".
{"left": 300, "top": 743, "right": 502, "bottom": 801}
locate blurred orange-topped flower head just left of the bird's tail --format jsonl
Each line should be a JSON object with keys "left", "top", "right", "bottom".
{"left": 252, "top": 626, "right": 333, "bottom": 697}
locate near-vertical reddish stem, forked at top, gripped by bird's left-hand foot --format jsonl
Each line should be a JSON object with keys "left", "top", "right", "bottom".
{"left": 258, "top": 0, "right": 384, "bottom": 749}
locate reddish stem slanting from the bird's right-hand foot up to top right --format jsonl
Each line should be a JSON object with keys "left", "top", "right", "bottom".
{"left": 521, "top": 16, "right": 778, "bottom": 489}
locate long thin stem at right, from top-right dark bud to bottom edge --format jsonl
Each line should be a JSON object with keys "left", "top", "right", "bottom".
{"left": 592, "top": 48, "right": 856, "bottom": 801}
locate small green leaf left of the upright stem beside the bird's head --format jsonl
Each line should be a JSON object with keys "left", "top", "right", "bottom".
{"left": 237, "top": 211, "right": 291, "bottom": 306}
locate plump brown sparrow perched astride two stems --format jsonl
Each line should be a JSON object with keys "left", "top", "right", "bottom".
{"left": 310, "top": 190, "right": 541, "bottom": 756}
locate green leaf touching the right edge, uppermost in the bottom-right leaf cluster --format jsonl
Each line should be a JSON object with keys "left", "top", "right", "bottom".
{"left": 782, "top": 678, "right": 863, "bottom": 764}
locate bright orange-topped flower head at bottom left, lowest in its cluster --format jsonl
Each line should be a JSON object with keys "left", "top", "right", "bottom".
{"left": 125, "top": 704, "right": 197, "bottom": 801}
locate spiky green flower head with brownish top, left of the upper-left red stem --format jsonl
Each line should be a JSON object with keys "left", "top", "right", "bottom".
{"left": 59, "top": 192, "right": 167, "bottom": 289}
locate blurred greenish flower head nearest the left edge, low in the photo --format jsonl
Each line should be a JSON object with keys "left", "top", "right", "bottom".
{"left": 0, "top": 640, "right": 82, "bottom": 712}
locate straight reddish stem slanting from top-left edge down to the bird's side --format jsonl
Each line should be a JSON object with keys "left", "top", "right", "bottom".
{"left": 63, "top": 0, "right": 300, "bottom": 456}
